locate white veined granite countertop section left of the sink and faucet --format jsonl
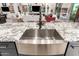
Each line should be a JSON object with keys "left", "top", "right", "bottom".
{"left": 0, "top": 23, "right": 38, "bottom": 41}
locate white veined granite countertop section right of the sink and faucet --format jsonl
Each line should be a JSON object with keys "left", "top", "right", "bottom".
{"left": 43, "top": 22, "right": 79, "bottom": 41}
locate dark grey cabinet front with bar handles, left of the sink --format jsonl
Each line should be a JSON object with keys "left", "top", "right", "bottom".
{"left": 0, "top": 42, "right": 18, "bottom": 56}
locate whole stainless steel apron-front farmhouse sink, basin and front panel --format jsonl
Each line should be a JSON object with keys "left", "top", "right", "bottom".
{"left": 16, "top": 29, "right": 67, "bottom": 55}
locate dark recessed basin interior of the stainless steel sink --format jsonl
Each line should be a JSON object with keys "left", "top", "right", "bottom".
{"left": 20, "top": 29, "right": 63, "bottom": 40}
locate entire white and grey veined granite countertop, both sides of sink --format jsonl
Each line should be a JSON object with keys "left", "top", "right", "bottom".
{"left": 0, "top": 22, "right": 79, "bottom": 41}
